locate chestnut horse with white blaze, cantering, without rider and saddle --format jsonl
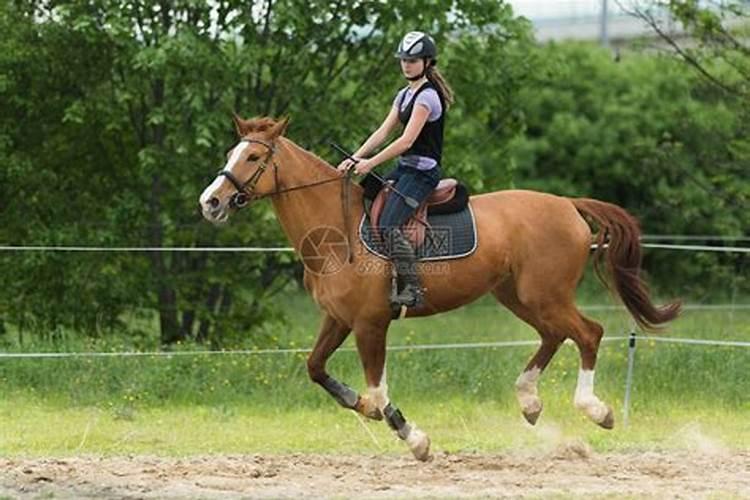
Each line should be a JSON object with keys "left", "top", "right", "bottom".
{"left": 199, "top": 115, "right": 681, "bottom": 461}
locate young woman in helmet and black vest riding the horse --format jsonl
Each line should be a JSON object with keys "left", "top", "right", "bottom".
{"left": 338, "top": 31, "right": 453, "bottom": 307}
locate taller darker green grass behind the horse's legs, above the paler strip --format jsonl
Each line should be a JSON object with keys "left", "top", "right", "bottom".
{"left": 0, "top": 293, "right": 750, "bottom": 409}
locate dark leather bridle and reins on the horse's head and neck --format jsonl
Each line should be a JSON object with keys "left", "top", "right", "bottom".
{"left": 218, "top": 137, "right": 353, "bottom": 263}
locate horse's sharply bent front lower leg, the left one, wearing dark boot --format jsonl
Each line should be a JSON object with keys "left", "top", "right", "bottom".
{"left": 307, "top": 315, "right": 383, "bottom": 420}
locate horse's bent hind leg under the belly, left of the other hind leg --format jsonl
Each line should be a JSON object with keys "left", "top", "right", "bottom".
{"left": 493, "top": 282, "right": 565, "bottom": 425}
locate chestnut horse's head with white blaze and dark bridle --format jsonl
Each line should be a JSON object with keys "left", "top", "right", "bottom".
{"left": 199, "top": 115, "right": 289, "bottom": 223}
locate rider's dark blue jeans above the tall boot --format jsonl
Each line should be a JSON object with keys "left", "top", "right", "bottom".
{"left": 380, "top": 162, "right": 440, "bottom": 233}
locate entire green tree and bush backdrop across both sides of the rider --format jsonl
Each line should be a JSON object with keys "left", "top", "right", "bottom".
{"left": 0, "top": 0, "right": 750, "bottom": 347}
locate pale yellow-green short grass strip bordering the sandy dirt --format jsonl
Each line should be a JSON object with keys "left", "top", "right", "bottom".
{"left": 0, "top": 397, "right": 750, "bottom": 456}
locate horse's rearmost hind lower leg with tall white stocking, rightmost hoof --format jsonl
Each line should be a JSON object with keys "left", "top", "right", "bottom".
{"left": 571, "top": 310, "right": 615, "bottom": 429}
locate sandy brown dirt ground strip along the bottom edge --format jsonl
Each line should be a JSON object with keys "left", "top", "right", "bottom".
{"left": 0, "top": 444, "right": 750, "bottom": 499}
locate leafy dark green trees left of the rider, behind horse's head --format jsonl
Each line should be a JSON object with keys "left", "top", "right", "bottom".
{"left": 0, "top": 0, "right": 529, "bottom": 346}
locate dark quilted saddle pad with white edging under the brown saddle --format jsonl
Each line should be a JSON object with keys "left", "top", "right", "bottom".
{"left": 359, "top": 202, "right": 477, "bottom": 261}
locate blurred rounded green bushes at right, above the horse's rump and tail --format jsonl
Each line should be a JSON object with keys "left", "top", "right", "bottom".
{"left": 510, "top": 43, "right": 750, "bottom": 297}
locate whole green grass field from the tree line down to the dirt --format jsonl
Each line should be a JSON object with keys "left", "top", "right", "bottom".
{"left": 0, "top": 294, "right": 750, "bottom": 456}
